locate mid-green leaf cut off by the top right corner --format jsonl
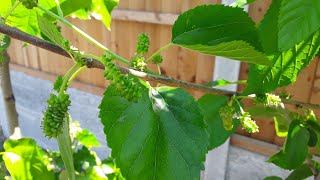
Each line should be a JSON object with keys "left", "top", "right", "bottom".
{"left": 278, "top": 0, "right": 320, "bottom": 50}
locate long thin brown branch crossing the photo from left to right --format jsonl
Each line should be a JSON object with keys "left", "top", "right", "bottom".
{"left": 0, "top": 24, "right": 320, "bottom": 109}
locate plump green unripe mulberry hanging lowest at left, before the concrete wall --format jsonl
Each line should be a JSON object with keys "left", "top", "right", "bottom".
{"left": 42, "top": 94, "right": 71, "bottom": 138}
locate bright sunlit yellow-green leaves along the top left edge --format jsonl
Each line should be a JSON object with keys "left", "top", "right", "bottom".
{"left": 0, "top": 0, "right": 118, "bottom": 35}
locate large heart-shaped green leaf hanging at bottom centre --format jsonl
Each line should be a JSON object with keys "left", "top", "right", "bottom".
{"left": 99, "top": 86, "right": 208, "bottom": 179}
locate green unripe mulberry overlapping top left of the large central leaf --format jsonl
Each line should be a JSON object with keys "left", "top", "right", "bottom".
{"left": 104, "top": 62, "right": 141, "bottom": 102}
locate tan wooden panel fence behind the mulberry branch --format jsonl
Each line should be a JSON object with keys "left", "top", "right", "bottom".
{"left": 6, "top": 0, "right": 320, "bottom": 150}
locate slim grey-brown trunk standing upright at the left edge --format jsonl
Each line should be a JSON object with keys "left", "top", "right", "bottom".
{"left": 0, "top": 52, "right": 20, "bottom": 138}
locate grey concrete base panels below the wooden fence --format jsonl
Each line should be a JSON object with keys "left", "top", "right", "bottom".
{"left": 0, "top": 71, "right": 302, "bottom": 180}
